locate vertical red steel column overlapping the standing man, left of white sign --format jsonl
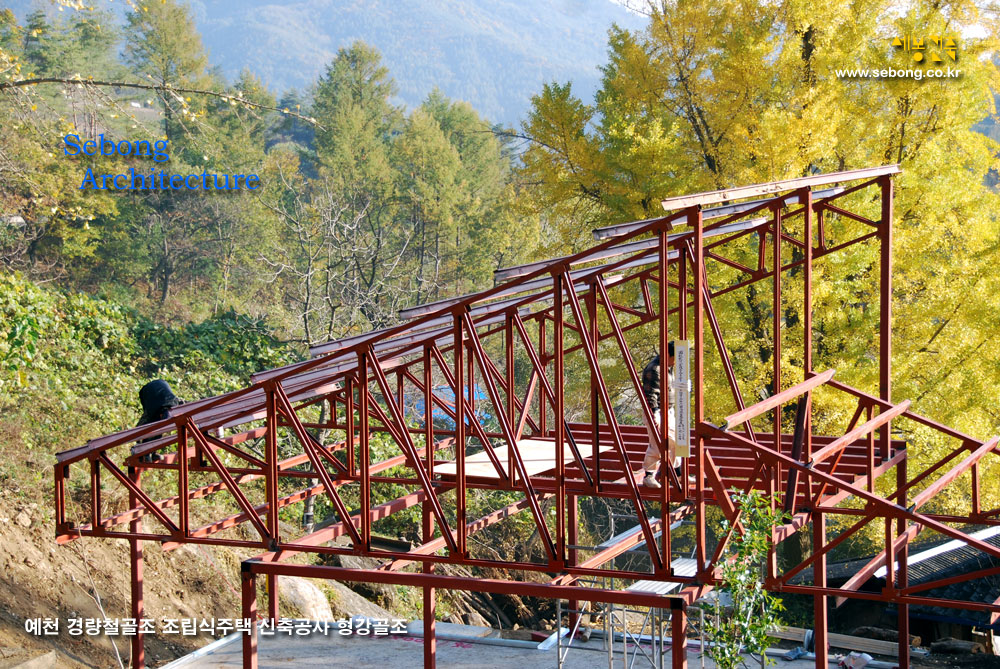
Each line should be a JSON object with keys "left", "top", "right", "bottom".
{"left": 655, "top": 228, "right": 687, "bottom": 574}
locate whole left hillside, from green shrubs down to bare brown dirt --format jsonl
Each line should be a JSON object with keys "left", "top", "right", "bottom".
{"left": 0, "top": 273, "right": 304, "bottom": 667}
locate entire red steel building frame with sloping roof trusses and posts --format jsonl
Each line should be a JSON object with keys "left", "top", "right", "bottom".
{"left": 55, "top": 166, "right": 1000, "bottom": 667}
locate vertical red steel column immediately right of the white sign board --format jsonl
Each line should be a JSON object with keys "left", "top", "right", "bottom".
{"left": 692, "top": 206, "right": 707, "bottom": 576}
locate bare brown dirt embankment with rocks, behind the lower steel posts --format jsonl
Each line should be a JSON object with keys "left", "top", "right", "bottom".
{"left": 0, "top": 488, "right": 543, "bottom": 669}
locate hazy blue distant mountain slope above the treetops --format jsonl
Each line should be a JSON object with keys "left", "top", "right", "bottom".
{"left": 7, "top": 0, "right": 645, "bottom": 125}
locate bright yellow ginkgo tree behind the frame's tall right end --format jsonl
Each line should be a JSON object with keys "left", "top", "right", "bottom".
{"left": 521, "top": 0, "right": 1000, "bottom": 544}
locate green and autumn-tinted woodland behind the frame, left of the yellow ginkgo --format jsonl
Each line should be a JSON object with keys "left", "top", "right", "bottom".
{"left": 0, "top": 1, "right": 537, "bottom": 344}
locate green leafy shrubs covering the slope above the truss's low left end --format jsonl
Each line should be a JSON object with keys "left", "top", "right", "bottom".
{"left": 0, "top": 274, "right": 295, "bottom": 488}
